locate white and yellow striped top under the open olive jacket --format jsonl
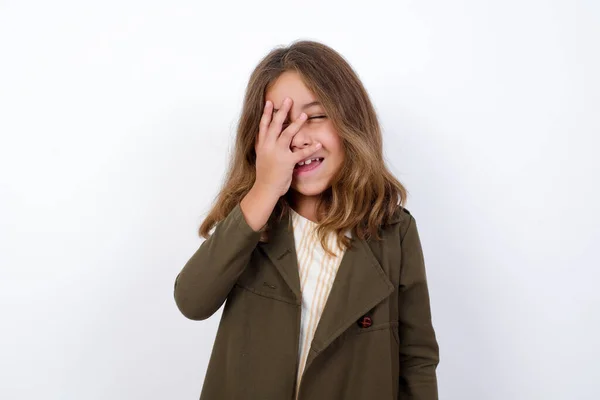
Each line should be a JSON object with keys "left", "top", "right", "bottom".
{"left": 290, "top": 209, "right": 351, "bottom": 396}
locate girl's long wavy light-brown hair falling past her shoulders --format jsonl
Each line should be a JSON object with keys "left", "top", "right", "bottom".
{"left": 199, "top": 40, "right": 406, "bottom": 254}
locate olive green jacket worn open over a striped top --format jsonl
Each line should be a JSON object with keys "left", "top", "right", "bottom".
{"left": 174, "top": 204, "right": 439, "bottom": 400}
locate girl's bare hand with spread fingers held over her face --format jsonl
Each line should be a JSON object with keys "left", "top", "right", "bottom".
{"left": 254, "top": 97, "right": 321, "bottom": 198}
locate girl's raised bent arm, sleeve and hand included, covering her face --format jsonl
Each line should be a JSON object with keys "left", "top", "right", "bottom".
{"left": 174, "top": 98, "right": 321, "bottom": 320}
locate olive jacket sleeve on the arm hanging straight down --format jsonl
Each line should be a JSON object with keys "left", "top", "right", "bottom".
{"left": 398, "top": 213, "right": 439, "bottom": 400}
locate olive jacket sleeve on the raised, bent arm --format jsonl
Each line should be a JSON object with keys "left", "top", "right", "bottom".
{"left": 174, "top": 203, "right": 261, "bottom": 320}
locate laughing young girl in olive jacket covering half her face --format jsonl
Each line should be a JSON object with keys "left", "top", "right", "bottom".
{"left": 174, "top": 41, "right": 438, "bottom": 400}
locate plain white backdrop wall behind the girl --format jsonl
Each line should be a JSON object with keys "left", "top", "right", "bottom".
{"left": 0, "top": 0, "right": 600, "bottom": 400}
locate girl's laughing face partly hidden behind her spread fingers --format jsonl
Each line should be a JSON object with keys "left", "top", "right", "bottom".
{"left": 266, "top": 71, "right": 344, "bottom": 197}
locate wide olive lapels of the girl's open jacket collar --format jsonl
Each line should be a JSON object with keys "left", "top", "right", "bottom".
{"left": 260, "top": 214, "right": 395, "bottom": 370}
